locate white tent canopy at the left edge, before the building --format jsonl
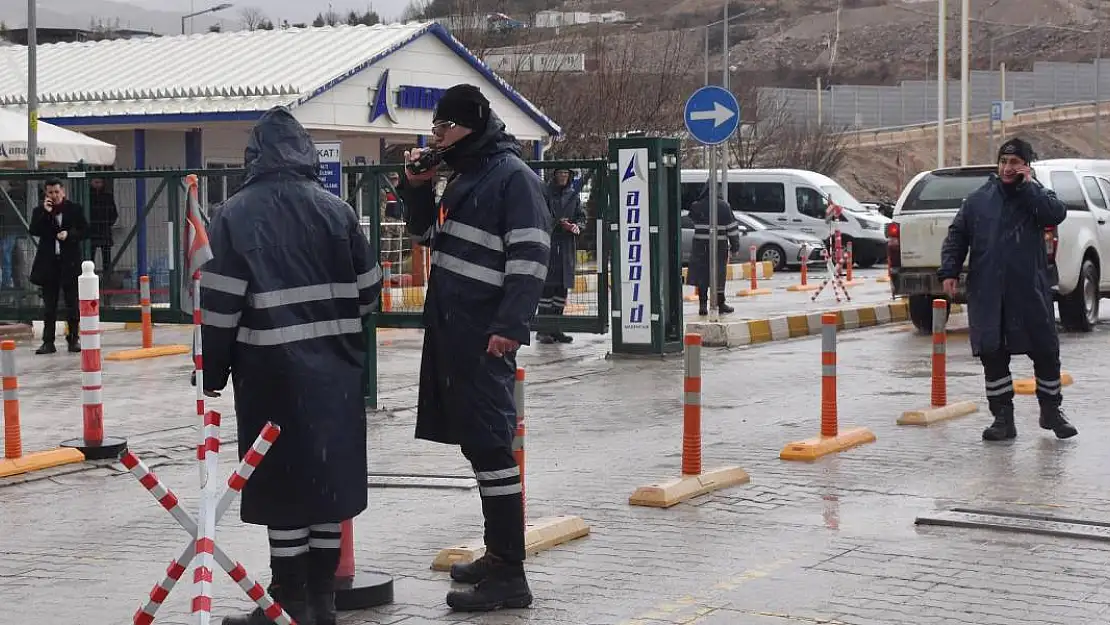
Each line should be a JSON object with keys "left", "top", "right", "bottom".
{"left": 0, "top": 109, "right": 115, "bottom": 168}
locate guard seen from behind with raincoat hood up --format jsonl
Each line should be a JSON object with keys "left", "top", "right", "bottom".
{"left": 201, "top": 108, "right": 382, "bottom": 625}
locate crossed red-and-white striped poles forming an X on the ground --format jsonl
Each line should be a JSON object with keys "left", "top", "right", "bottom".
{"left": 122, "top": 423, "right": 295, "bottom": 625}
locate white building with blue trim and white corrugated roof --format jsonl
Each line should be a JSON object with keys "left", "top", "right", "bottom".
{"left": 0, "top": 22, "right": 561, "bottom": 280}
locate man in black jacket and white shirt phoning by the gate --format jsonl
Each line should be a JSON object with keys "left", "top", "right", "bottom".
{"left": 30, "top": 178, "right": 89, "bottom": 354}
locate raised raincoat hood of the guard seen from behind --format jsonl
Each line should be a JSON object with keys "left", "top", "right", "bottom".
{"left": 243, "top": 107, "right": 320, "bottom": 184}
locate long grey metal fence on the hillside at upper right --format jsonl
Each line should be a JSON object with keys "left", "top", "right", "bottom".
{"left": 759, "top": 59, "right": 1110, "bottom": 130}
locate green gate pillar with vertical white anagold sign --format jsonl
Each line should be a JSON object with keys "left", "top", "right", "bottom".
{"left": 608, "top": 137, "right": 684, "bottom": 356}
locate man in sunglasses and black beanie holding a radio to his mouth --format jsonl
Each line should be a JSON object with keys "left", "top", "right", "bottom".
{"left": 400, "top": 84, "right": 552, "bottom": 612}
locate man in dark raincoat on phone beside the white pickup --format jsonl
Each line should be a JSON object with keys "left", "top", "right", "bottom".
{"left": 937, "top": 139, "right": 1078, "bottom": 441}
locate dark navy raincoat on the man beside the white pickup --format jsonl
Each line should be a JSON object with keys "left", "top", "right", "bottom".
{"left": 937, "top": 175, "right": 1068, "bottom": 356}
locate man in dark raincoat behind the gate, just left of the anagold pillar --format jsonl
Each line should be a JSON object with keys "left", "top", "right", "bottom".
{"left": 536, "top": 169, "right": 586, "bottom": 344}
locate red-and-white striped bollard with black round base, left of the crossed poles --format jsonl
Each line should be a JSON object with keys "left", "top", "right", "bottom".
{"left": 61, "top": 261, "right": 128, "bottom": 460}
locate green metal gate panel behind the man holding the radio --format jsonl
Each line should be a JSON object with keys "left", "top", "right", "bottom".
{"left": 343, "top": 160, "right": 617, "bottom": 409}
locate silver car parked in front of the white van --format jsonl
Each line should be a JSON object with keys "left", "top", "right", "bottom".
{"left": 682, "top": 211, "right": 825, "bottom": 271}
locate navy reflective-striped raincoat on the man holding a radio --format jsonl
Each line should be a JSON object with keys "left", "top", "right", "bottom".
{"left": 400, "top": 114, "right": 552, "bottom": 452}
